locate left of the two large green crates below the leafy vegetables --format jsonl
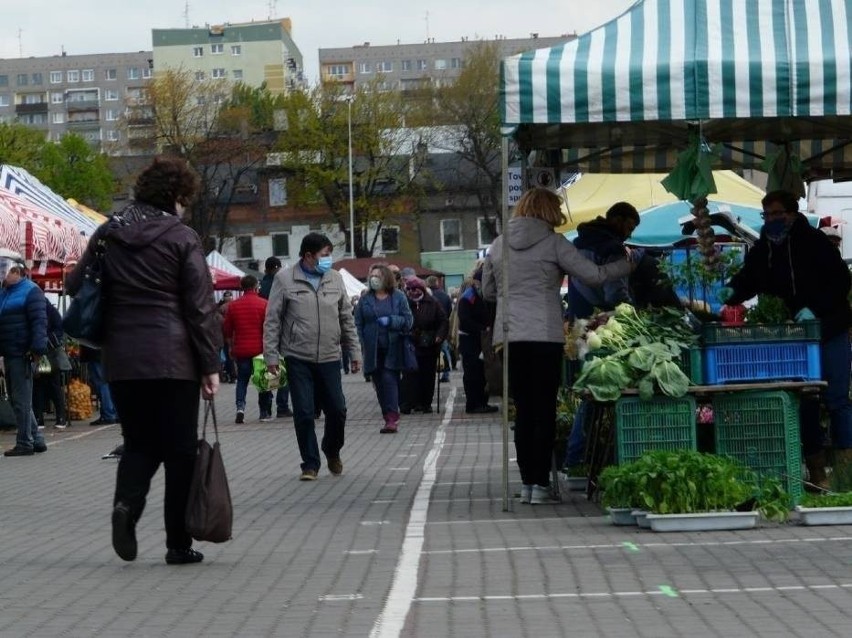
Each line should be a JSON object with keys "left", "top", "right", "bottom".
{"left": 615, "top": 396, "right": 698, "bottom": 463}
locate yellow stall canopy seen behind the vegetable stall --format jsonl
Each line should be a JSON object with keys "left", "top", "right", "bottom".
{"left": 556, "top": 171, "right": 764, "bottom": 232}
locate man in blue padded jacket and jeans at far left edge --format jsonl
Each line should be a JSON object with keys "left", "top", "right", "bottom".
{"left": 0, "top": 257, "right": 47, "bottom": 456}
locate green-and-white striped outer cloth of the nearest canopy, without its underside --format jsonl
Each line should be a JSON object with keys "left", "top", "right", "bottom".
{"left": 503, "top": 0, "right": 852, "bottom": 124}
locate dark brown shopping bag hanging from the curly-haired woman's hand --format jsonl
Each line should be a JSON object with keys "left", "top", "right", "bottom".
{"left": 186, "top": 399, "right": 234, "bottom": 543}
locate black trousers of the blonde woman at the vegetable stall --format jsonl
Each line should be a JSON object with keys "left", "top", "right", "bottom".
{"left": 509, "top": 341, "right": 563, "bottom": 486}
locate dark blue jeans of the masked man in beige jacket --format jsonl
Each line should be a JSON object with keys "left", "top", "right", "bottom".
{"left": 286, "top": 357, "right": 346, "bottom": 471}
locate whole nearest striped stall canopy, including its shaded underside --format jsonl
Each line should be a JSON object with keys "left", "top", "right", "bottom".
{"left": 501, "top": 0, "right": 852, "bottom": 178}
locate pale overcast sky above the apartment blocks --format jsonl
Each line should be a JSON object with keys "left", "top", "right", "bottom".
{"left": 0, "top": 0, "right": 635, "bottom": 81}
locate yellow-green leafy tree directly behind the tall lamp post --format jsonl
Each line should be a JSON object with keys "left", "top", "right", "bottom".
{"left": 278, "top": 77, "right": 428, "bottom": 257}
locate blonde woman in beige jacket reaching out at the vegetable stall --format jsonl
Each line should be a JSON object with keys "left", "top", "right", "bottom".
{"left": 482, "top": 188, "right": 632, "bottom": 504}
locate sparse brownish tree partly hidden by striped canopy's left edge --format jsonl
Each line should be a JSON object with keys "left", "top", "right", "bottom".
{"left": 433, "top": 41, "right": 503, "bottom": 235}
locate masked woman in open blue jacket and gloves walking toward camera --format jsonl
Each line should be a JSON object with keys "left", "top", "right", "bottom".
{"left": 355, "top": 264, "right": 413, "bottom": 434}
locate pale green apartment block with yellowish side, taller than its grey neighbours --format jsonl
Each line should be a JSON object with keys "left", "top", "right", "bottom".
{"left": 151, "top": 18, "right": 304, "bottom": 93}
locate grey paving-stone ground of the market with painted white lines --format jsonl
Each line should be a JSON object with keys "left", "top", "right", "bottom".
{"left": 0, "top": 373, "right": 852, "bottom": 638}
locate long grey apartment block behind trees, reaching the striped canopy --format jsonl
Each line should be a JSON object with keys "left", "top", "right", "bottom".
{"left": 319, "top": 33, "right": 576, "bottom": 91}
